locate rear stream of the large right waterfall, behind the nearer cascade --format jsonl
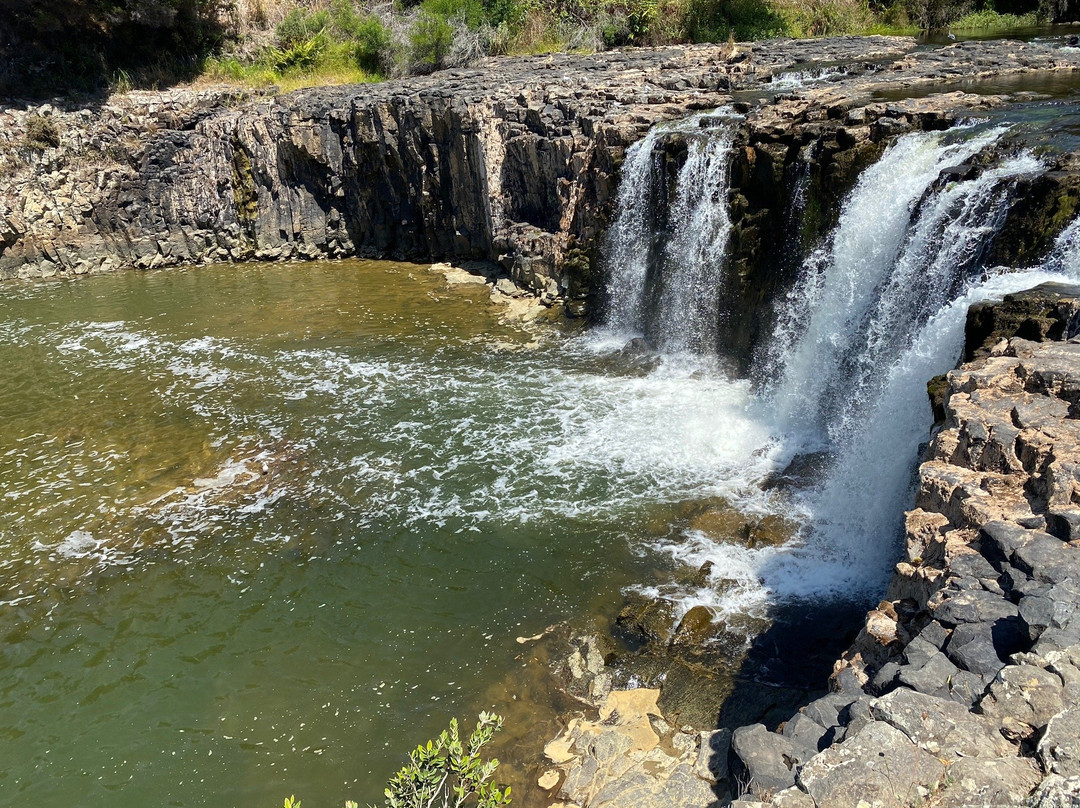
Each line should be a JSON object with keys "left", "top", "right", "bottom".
{"left": 766, "top": 127, "right": 1004, "bottom": 446}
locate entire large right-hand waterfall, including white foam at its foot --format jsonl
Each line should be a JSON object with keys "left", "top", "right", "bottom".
{"left": 604, "top": 119, "right": 1080, "bottom": 614}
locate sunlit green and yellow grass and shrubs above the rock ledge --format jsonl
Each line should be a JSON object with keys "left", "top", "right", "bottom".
{"left": 183, "top": 0, "right": 1062, "bottom": 92}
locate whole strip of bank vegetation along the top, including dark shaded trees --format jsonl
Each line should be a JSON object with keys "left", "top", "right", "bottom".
{"left": 0, "top": 0, "right": 1080, "bottom": 96}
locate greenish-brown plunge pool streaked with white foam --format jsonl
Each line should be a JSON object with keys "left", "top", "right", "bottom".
{"left": 0, "top": 261, "right": 777, "bottom": 808}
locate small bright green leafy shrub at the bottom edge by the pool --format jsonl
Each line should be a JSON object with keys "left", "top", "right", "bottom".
{"left": 369, "top": 713, "right": 510, "bottom": 808}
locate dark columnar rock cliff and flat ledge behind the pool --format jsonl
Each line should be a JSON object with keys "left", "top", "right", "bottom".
{"left": 6, "top": 37, "right": 1080, "bottom": 339}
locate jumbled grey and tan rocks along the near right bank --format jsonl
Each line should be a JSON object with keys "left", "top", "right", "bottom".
{"left": 541, "top": 286, "right": 1080, "bottom": 808}
